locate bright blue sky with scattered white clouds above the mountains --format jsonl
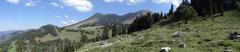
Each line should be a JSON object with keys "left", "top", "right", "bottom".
{"left": 0, "top": 0, "right": 184, "bottom": 31}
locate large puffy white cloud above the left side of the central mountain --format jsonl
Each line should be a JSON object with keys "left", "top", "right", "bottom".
{"left": 63, "top": 0, "right": 93, "bottom": 12}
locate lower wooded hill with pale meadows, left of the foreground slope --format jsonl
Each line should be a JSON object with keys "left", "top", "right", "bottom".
{"left": 0, "top": 27, "right": 106, "bottom": 52}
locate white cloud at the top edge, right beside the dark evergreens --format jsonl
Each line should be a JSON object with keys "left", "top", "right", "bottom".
{"left": 152, "top": 0, "right": 182, "bottom": 7}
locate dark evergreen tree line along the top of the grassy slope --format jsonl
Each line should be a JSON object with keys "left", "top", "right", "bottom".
{"left": 128, "top": 0, "right": 240, "bottom": 33}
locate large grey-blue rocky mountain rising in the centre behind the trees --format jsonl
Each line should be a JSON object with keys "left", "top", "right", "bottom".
{"left": 67, "top": 10, "right": 151, "bottom": 28}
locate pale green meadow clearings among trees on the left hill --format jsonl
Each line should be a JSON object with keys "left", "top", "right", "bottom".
{"left": 35, "top": 27, "right": 102, "bottom": 42}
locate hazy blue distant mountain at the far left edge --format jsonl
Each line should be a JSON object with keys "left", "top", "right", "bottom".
{"left": 0, "top": 30, "right": 21, "bottom": 42}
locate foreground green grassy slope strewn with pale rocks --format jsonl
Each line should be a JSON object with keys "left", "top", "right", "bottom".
{"left": 77, "top": 11, "right": 240, "bottom": 52}
